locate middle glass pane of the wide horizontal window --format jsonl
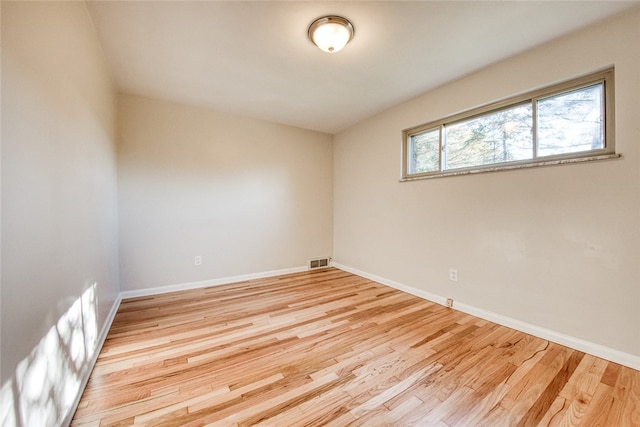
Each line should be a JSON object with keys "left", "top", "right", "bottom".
{"left": 445, "top": 103, "right": 533, "bottom": 169}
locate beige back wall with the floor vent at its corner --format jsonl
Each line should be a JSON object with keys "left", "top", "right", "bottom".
{"left": 118, "top": 95, "right": 333, "bottom": 290}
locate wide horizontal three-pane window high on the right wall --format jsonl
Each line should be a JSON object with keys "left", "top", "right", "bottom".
{"left": 402, "top": 69, "right": 615, "bottom": 179}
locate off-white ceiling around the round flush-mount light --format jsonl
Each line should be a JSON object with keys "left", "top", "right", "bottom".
{"left": 87, "top": 1, "right": 640, "bottom": 133}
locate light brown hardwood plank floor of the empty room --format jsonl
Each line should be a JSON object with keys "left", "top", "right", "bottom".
{"left": 72, "top": 269, "right": 640, "bottom": 426}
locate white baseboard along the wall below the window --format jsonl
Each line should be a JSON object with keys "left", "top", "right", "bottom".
{"left": 333, "top": 262, "right": 640, "bottom": 370}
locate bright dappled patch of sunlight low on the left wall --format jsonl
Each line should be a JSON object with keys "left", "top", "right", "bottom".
{"left": 0, "top": 283, "right": 98, "bottom": 427}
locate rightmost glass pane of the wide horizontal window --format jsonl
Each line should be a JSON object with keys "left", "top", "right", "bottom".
{"left": 537, "top": 83, "right": 604, "bottom": 156}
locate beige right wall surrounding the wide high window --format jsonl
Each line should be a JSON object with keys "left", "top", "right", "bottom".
{"left": 334, "top": 8, "right": 640, "bottom": 356}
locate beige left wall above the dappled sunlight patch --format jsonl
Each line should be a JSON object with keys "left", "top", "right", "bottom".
{"left": 1, "top": 1, "right": 119, "bottom": 392}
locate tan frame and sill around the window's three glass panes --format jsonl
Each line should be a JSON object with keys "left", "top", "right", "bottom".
{"left": 401, "top": 68, "right": 620, "bottom": 181}
